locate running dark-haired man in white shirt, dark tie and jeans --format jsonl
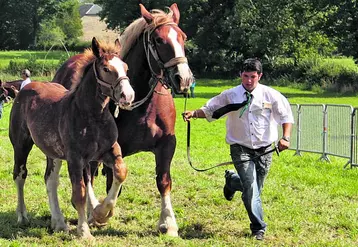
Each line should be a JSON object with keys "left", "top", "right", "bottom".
{"left": 183, "top": 58, "right": 293, "bottom": 240}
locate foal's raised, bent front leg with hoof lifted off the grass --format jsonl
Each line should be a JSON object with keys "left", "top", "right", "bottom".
{"left": 93, "top": 142, "right": 127, "bottom": 224}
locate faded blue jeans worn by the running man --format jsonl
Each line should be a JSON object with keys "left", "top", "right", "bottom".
{"left": 228, "top": 144, "right": 272, "bottom": 233}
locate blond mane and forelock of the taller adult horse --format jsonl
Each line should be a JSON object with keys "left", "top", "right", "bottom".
{"left": 120, "top": 8, "right": 185, "bottom": 58}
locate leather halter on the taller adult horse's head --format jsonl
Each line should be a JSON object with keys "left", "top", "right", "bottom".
{"left": 143, "top": 22, "right": 188, "bottom": 88}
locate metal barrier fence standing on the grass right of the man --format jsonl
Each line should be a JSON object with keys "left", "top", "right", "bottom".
{"left": 281, "top": 104, "right": 358, "bottom": 167}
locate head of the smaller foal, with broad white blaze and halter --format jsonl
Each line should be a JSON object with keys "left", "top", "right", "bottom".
{"left": 92, "top": 38, "right": 134, "bottom": 109}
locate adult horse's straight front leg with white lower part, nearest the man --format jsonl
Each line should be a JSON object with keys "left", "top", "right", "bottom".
{"left": 155, "top": 136, "right": 178, "bottom": 237}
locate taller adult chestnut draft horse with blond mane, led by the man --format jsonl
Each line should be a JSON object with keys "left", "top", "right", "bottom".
{"left": 53, "top": 4, "right": 193, "bottom": 236}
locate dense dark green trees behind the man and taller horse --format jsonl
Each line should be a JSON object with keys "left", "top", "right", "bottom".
{"left": 95, "top": 0, "right": 358, "bottom": 73}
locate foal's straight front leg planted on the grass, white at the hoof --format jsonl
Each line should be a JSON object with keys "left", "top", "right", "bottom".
{"left": 67, "top": 159, "right": 93, "bottom": 239}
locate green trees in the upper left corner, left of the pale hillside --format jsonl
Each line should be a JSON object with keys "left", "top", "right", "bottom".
{"left": 0, "top": 0, "right": 82, "bottom": 50}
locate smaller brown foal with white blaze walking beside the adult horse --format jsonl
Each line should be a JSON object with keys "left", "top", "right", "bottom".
{"left": 9, "top": 38, "right": 134, "bottom": 238}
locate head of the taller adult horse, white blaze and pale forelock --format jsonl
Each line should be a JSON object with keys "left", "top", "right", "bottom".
{"left": 140, "top": 3, "right": 193, "bottom": 93}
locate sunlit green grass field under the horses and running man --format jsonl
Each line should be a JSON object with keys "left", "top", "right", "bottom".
{"left": 0, "top": 79, "right": 358, "bottom": 247}
